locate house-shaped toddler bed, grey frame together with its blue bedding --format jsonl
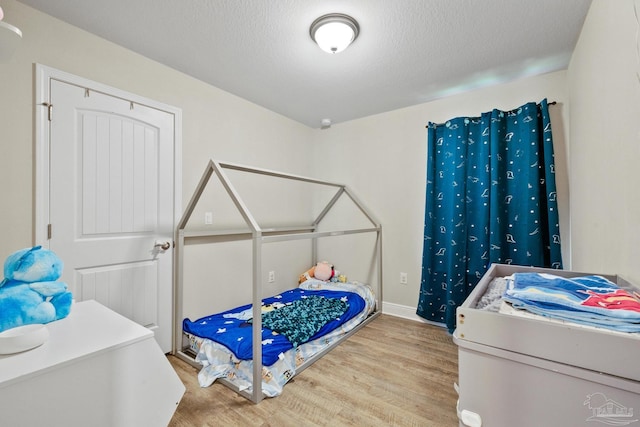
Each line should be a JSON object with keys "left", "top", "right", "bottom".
{"left": 172, "top": 160, "right": 383, "bottom": 403}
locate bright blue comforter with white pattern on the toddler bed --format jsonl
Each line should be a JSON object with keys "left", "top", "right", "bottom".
{"left": 182, "top": 288, "right": 365, "bottom": 366}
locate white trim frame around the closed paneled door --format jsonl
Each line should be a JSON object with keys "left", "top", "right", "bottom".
{"left": 33, "top": 64, "right": 182, "bottom": 344}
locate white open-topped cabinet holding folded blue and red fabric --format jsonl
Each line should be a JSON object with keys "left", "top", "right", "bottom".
{"left": 454, "top": 264, "right": 640, "bottom": 427}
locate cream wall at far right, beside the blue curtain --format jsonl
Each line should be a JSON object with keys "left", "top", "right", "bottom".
{"left": 567, "top": 0, "right": 640, "bottom": 283}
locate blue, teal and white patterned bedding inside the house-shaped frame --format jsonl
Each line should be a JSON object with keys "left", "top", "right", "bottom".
{"left": 183, "top": 279, "right": 375, "bottom": 397}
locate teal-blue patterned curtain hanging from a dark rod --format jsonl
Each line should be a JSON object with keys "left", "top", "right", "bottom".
{"left": 417, "top": 100, "right": 562, "bottom": 331}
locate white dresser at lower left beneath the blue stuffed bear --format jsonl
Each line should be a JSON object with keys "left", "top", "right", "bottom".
{"left": 0, "top": 301, "right": 185, "bottom": 427}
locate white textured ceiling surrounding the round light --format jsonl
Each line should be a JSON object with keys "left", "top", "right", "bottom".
{"left": 19, "top": 0, "right": 590, "bottom": 128}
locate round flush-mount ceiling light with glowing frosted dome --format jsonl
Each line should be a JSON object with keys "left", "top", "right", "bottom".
{"left": 309, "top": 13, "right": 360, "bottom": 53}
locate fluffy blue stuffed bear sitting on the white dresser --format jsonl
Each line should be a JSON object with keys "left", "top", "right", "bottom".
{"left": 0, "top": 246, "right": 73, "bottom": 332}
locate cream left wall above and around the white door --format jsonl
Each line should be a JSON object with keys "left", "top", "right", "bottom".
{"left": 0, "top": 0, "right": 312, "bottom": 261}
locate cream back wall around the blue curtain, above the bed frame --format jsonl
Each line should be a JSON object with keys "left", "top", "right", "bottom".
{"left": 313, "top": 71, "right": 570, "bottom": 317}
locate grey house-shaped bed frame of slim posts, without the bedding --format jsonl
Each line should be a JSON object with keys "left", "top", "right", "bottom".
{"left": 172, "top": 160, "right": 382, "bottom": 403}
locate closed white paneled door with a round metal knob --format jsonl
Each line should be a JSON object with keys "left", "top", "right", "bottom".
{"left": 37, "top": 70, "right": 175, "bottom": 352}
